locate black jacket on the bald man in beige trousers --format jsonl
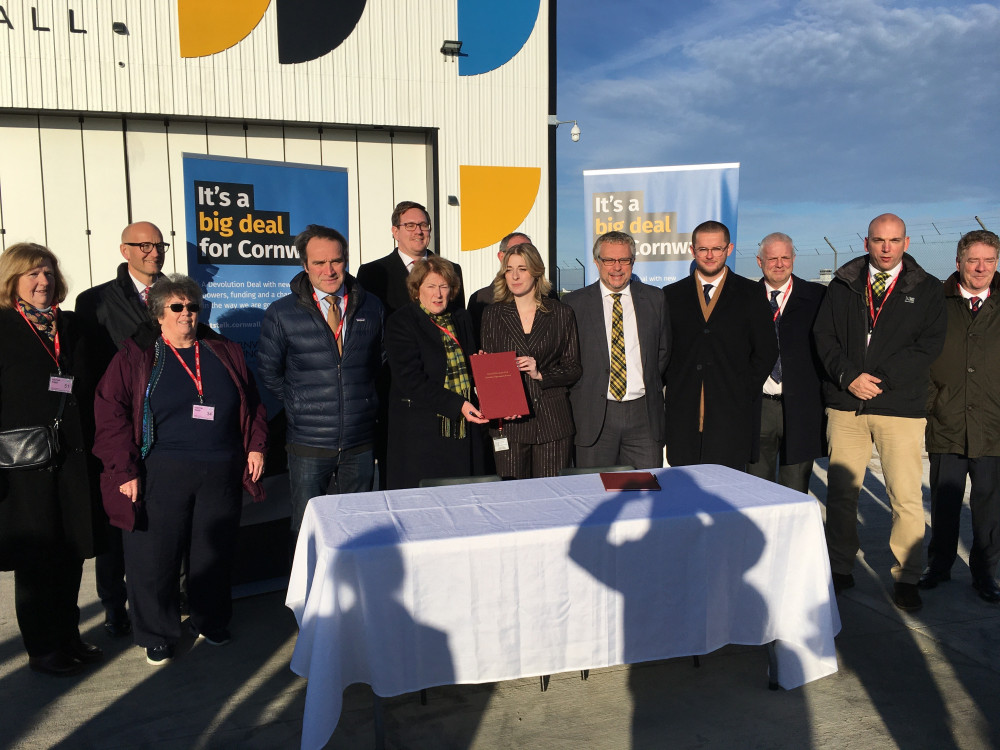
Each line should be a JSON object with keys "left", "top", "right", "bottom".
{"left": 813, "top": 255, "right": 947, "bottom": 418}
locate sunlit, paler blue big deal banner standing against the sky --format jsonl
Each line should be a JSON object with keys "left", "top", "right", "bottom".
{"left": 583, "top": 163, "right": 740, "bottom": 286}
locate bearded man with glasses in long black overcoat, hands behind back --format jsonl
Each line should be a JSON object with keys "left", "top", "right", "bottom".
{"left": 663, "top": 221, "right": 778, "bottom": 471}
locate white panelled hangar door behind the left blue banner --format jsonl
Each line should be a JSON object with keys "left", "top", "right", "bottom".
{"left": 0, "top": 114, "right": 432, "bottom": 306}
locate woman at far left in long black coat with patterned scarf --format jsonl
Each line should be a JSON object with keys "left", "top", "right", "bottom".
{"left": 0, "top": 242, "right": 103, "bottom": 676}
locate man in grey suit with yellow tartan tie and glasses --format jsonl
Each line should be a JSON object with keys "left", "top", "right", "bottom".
{"left": 563, "top": 232, "right": 670, "bottom": 468}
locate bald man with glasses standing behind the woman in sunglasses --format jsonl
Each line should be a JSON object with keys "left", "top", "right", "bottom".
{"left": 76, "top": 221, "right": 170, "bottom": 638}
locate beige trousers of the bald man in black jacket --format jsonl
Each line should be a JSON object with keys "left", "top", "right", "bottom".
{"left": 826, "top": 408, "right": 927, "bottom": 583}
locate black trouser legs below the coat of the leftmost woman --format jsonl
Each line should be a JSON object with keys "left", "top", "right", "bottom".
{"left": 14, "top": 549, "right": 83, "bottom": 656}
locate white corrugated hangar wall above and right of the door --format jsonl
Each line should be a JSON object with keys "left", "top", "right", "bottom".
{"left": 0, "top": 0, "right": 548, "bottom": 296}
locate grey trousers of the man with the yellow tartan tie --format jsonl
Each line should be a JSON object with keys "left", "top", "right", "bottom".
{"left": 576, "top": 397, "right": 663, "bottom": 469}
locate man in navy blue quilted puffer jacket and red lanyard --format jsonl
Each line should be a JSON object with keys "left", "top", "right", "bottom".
{"left": 257, "top": 224, "right": 385, "bottom": 535}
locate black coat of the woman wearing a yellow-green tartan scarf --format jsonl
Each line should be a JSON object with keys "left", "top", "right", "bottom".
{"left": 385, "top": 302, "right": 483, "bottom": 489}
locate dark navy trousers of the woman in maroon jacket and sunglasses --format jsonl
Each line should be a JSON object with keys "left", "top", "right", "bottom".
{"left": 123, "top": 450, "right": 243, "bottom": 648}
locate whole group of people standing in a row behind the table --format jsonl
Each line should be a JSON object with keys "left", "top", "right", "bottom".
{"left": 0, "top": 201, "right": 1000, "bottom": 675}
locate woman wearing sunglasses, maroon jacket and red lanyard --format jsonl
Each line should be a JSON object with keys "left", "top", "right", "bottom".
{"left": 94, "top": 274, "right": 267, "bottom": 665}
